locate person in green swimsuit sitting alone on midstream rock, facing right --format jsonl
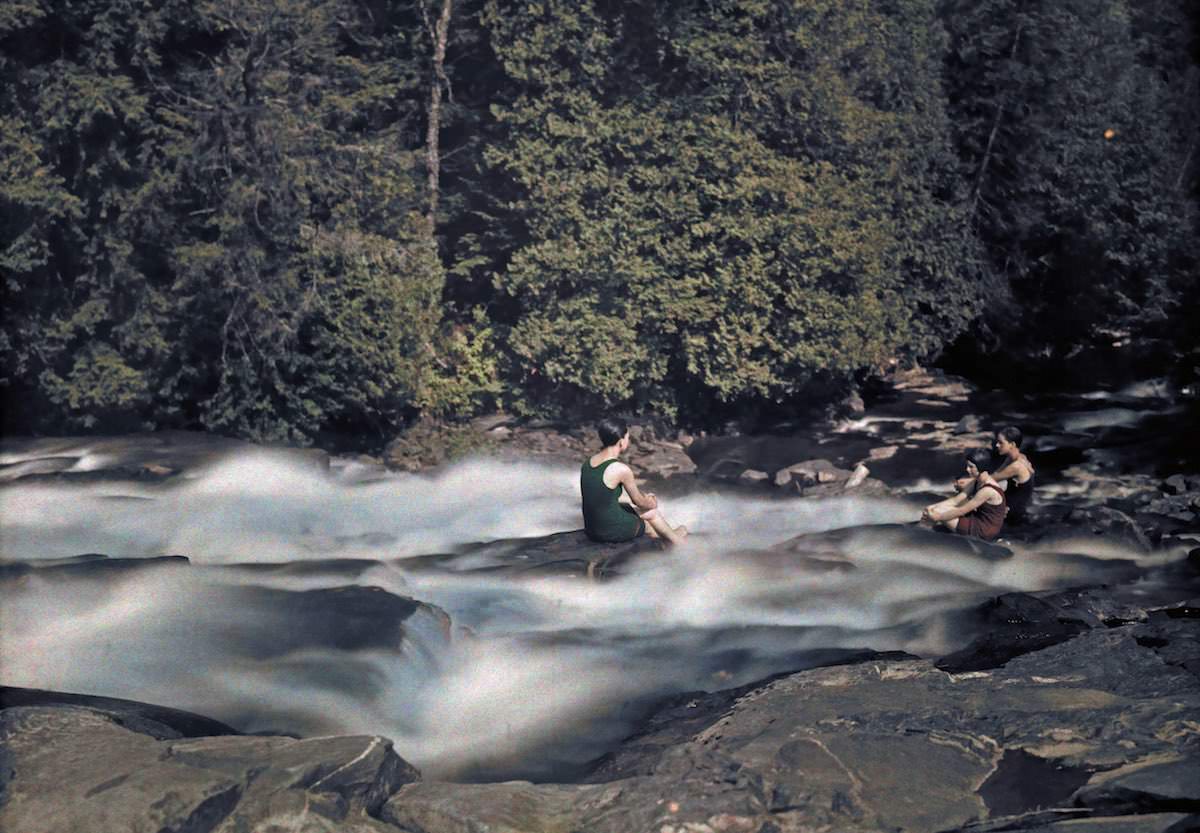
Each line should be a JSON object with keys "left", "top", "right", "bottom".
{"left": 580, "top": 417, "right": 688, "bottom": 545}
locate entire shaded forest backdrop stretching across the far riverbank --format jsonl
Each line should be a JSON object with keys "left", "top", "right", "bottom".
{"left": 0, "top": 0, "right": 1200, "bottom": 447}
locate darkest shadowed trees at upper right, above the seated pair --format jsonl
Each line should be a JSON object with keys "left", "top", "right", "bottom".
{"left": 944, "top": 0, "right": 1200, "bottom": 354}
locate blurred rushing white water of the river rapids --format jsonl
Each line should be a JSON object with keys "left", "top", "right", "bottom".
{"left": 0, "top": 454, "right": 1161, "bottom": 777}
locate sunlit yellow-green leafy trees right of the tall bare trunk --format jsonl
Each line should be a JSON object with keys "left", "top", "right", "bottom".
{"left": 485, "top": 0, "right": 977, "bottom": 417}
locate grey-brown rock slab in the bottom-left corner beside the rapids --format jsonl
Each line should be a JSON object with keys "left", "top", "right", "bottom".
{"left": 0, "top": 706, "right": 419, "bottom": 833}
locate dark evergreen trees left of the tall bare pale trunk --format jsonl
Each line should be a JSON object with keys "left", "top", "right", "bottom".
{"left": 2, "top": 0, "right": 443, "bottom": 441}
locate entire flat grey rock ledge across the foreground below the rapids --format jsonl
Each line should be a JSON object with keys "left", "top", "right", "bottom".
{"left": 0, "top": 597, "right": 1200, "bottom": 833}
